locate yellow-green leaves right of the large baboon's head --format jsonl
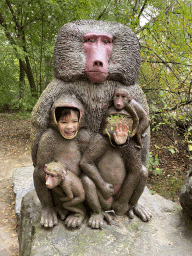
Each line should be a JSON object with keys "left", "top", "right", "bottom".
{"left": 139, "top": 0, "right": 192, "bottom": 142}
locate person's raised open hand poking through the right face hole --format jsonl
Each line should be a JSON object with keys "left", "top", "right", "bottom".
{"left": 113, "top": 122, "right": 129, "bottom": 145}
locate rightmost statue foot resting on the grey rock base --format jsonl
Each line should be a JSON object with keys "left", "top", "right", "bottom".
{"left": 128, "top": 205, "right": 152, "bottom": 222}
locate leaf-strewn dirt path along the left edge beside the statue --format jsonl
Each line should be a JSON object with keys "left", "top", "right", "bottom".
{"left": 0, "top": 113, "right": 32, "bottom": 256}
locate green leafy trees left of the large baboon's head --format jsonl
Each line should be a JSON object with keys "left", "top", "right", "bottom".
{"left": 0, "top": 0, "right": 115, "bottom": 107}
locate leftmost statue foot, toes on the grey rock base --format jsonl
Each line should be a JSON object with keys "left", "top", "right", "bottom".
{"left": 40, "top": 207, "right": 58, "bottom": 228}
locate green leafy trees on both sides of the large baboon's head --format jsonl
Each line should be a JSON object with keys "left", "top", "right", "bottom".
{"left": 0, "top": 0, "right": 192, "bottom": 122}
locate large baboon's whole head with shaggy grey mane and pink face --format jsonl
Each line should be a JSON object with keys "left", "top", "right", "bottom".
{"left": 53, "top": 20, "right": 141, "bottom": 86}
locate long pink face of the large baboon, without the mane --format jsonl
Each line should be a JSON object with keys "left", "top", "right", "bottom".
{"left": 83, "top": 33, "right": 113, "bottom": 83}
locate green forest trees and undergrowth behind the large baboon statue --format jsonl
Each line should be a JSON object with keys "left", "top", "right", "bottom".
{"left": 0, "top": 0, "right": 192, "bottom": 200}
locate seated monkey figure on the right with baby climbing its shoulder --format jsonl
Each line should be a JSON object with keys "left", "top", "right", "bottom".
{"left": 80, "top": 88, "right": 149, "bottom": 228}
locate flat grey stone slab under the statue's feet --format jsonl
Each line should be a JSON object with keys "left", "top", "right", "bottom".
{"left": 13, "top": 167, "right": 192, "bottom": 256}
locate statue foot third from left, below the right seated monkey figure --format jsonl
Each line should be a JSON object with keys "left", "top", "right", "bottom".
{"left": 88, "top": 212, "right": 113, "bottom": 229}
